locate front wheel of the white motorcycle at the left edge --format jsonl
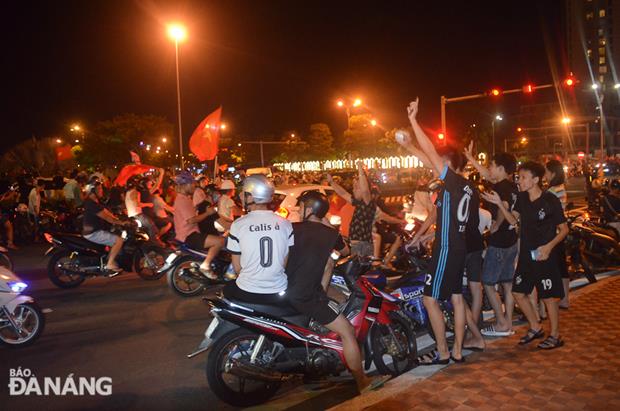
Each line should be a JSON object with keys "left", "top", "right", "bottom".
{"left": 0, "top": 303, "right": 45, "bottom": 348}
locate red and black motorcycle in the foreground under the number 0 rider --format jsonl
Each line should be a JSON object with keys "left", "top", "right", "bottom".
{"left": 188, "top": 258, "right": 417, "bottom": 406}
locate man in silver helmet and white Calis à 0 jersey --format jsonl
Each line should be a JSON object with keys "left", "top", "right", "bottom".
{"left": 224, "top": 174, "right": 294, "bottom": 304}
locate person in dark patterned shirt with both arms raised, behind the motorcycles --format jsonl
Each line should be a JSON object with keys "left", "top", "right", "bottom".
{"left": 327, "top": 161, "right": 377, "bottom": 256}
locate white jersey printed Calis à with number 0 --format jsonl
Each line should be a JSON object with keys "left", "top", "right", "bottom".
{"left": 226, "top": 210, "right": 294, "bottom": 294}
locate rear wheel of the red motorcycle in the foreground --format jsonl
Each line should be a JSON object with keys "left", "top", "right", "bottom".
{"left": 206, "top": 329, "right": 282, "bottom": 407}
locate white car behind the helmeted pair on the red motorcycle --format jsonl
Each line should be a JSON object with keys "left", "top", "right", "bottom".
{"left": 272, "top": 184, "right": 345, "bottom": 226}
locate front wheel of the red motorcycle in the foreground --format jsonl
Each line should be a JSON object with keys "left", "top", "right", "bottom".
{"left": 370, "top": 315, "right": 418, "bottom": 376}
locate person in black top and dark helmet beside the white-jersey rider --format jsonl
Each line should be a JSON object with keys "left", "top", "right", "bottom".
{"left": 286, "top": 191, "right": 386, "bottom": 392}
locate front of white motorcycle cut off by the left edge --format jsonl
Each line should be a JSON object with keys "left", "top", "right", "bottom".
{"left": 0, "top": 267, "right": 45, "bottom": 348}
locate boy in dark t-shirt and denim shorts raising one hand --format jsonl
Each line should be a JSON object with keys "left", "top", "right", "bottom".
{"left": 465, "top": 148, "right": 518, "bottom": 337}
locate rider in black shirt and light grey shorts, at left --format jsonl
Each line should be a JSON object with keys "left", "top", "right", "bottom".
{"left": 82, "top": 179, "right": 126, "bottom": 274}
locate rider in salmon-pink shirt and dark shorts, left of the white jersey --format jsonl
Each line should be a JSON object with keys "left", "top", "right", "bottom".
{"left": 174, "top": 171, "right": 224, "bottom": 280}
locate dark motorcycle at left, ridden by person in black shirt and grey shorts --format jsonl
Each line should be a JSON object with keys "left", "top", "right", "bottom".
{"left": 44, "top": 221, "right": 168, "bottom": 288}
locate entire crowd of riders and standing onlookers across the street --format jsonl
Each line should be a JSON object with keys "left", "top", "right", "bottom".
{"left": 0, "top": 101, "right": 620, "bottom": 391}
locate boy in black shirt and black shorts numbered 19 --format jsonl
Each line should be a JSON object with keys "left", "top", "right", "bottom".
{"left": 483, "top": 161, "right": 568, "bottom": 349}
